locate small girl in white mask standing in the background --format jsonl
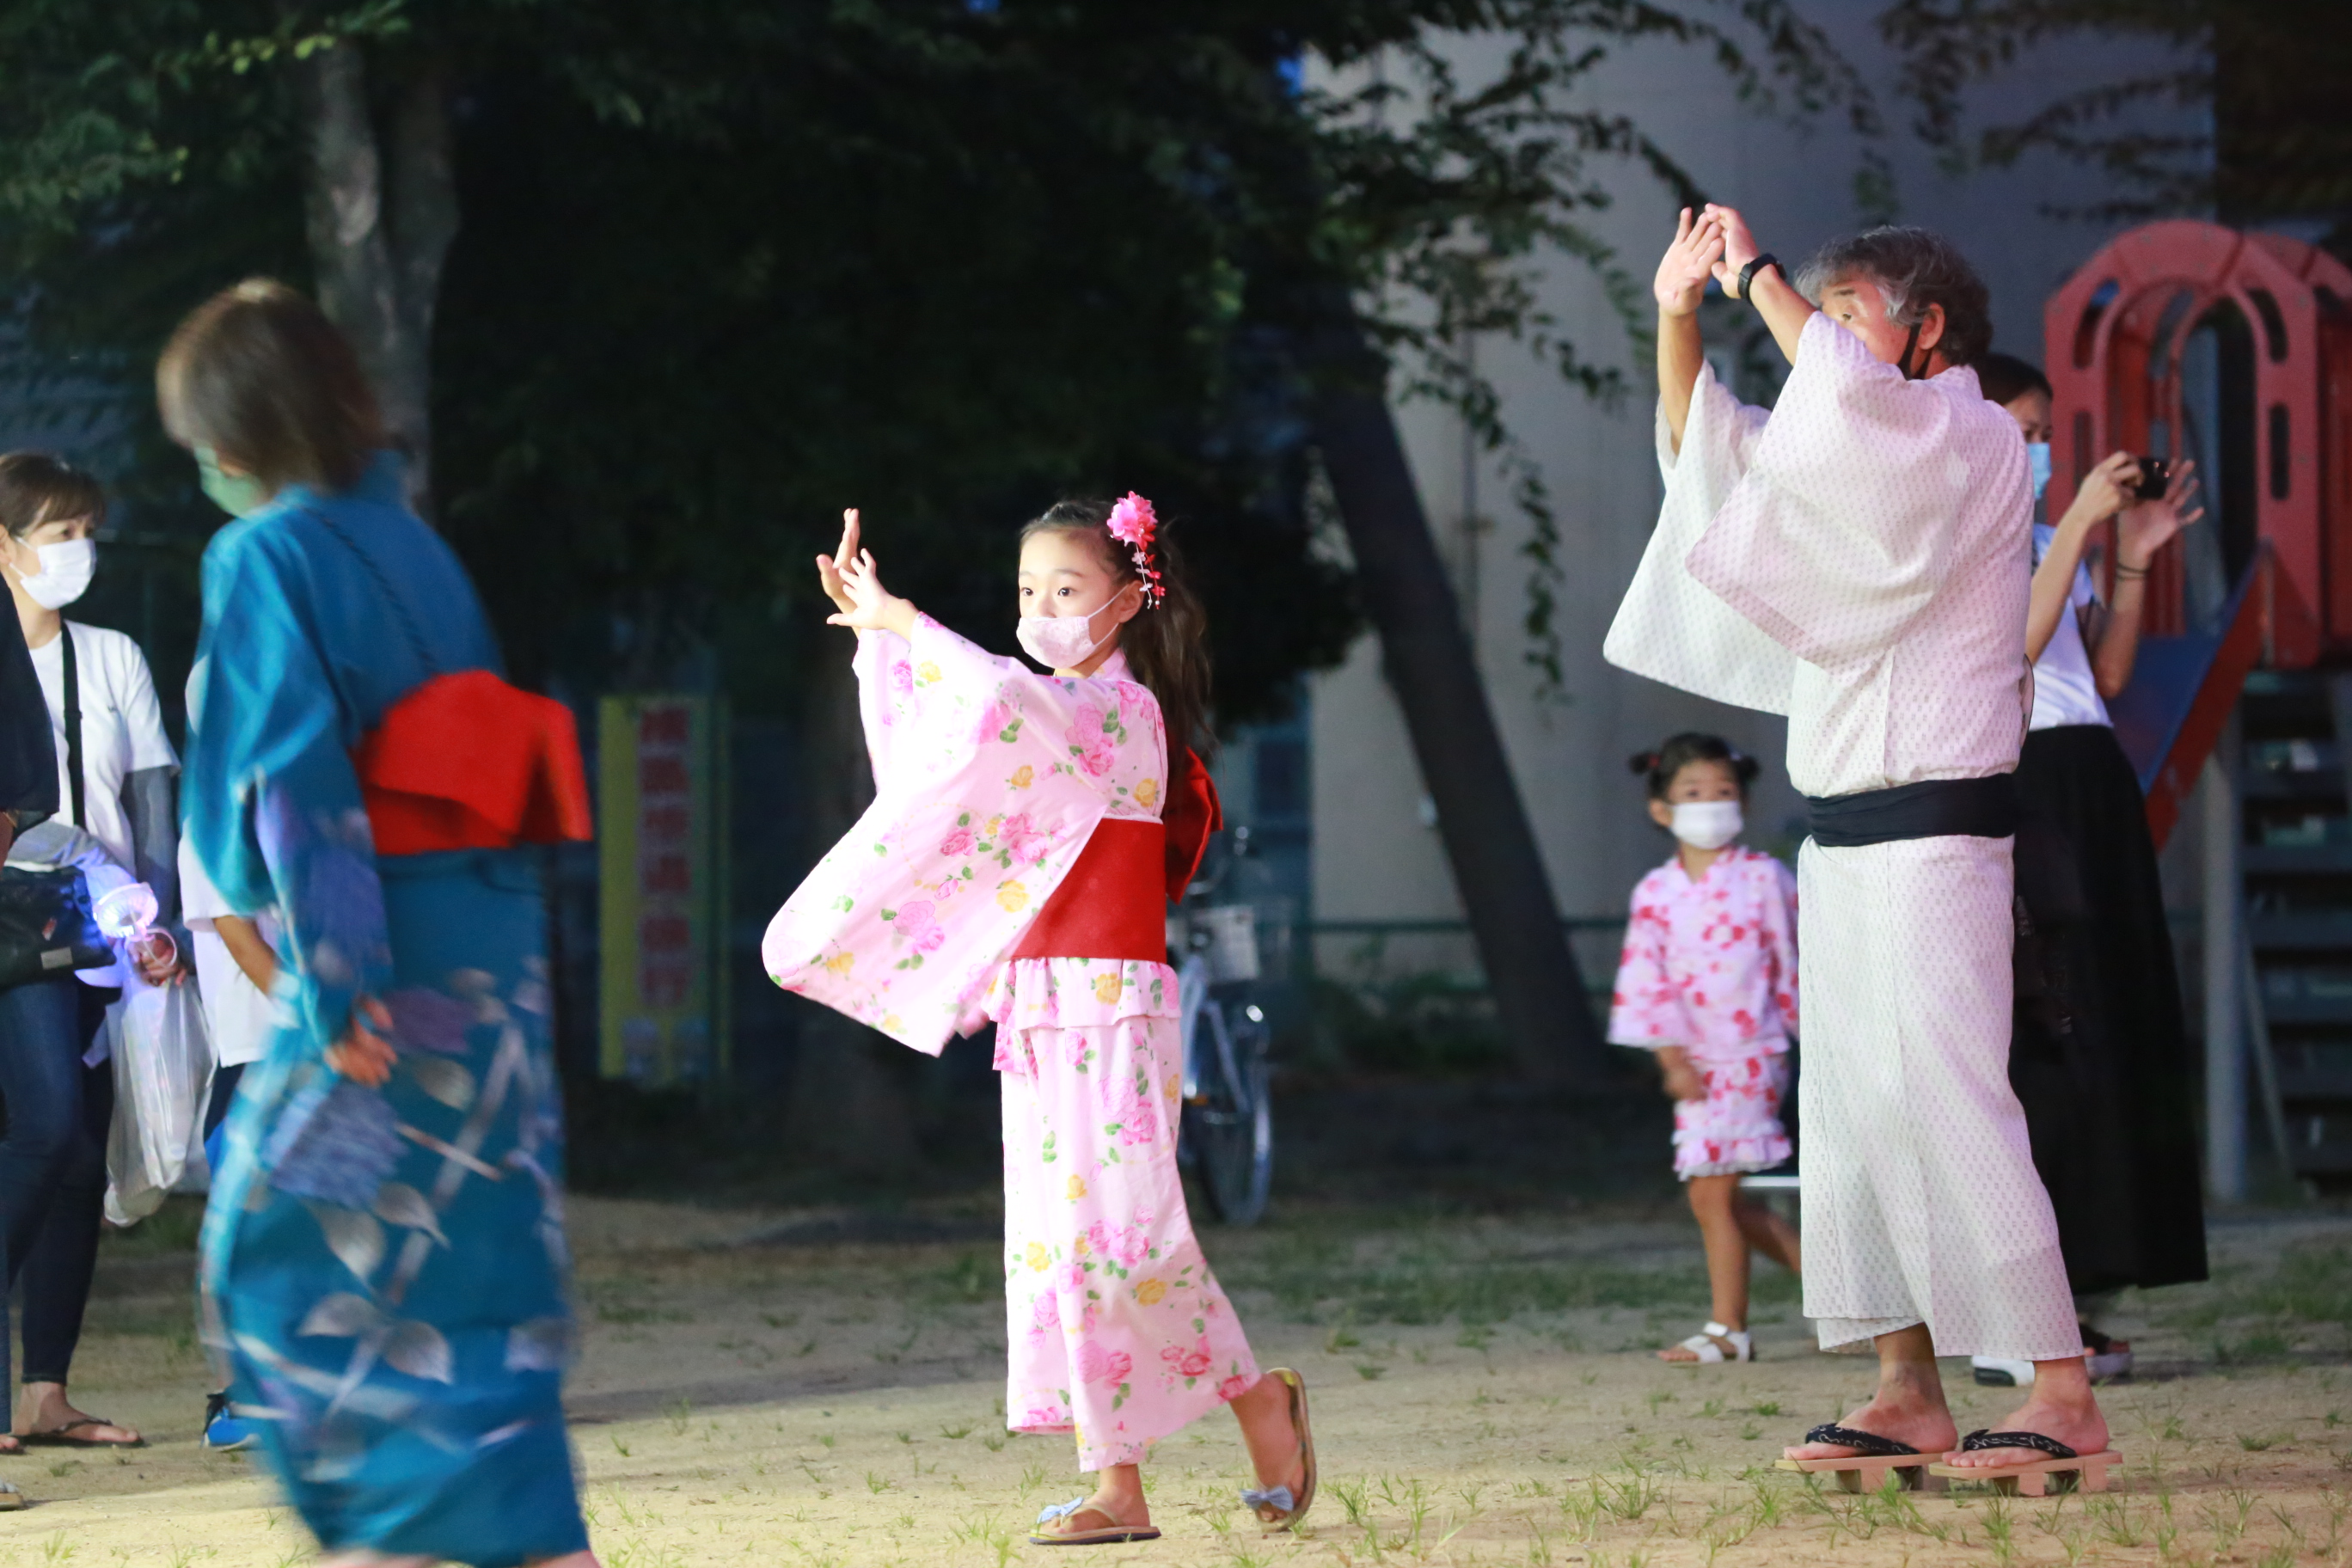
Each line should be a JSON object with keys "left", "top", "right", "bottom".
{"left": 1608, "top": 733, "right": 1797, "bottom": 1363}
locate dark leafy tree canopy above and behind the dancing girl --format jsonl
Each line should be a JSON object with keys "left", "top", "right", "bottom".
{"left": 0, "top": 0, "right": 1872, "bottom": 720}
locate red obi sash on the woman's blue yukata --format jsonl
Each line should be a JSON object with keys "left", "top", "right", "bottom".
{"left": 351, "top": 670, "right": 595, "bottom": 855}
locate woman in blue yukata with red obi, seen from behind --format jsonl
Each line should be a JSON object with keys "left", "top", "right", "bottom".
{"left": 156, "top": 282, "right": 595, "bottom": 1568}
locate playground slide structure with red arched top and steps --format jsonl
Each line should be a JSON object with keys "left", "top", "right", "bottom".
{"left": 2044, "top": 221, "right": 2352, "bottom": 1199}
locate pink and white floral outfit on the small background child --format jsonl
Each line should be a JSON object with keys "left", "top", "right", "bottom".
{"left": 1608, "top": 844, "right": 1797, "bottom": 1180}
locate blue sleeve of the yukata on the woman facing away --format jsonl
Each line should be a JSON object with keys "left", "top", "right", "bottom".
{"left": 183, "top": 519, "right": 393, "bottom": 1053}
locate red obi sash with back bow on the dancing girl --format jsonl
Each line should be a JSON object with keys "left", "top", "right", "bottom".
{"left": 1009, "top": 750, "right": 1225, "bottom": 964}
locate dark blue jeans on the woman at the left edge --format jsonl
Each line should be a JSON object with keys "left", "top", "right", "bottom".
{"left": 0, "top": 976, "right": 115, "bottom": 1389}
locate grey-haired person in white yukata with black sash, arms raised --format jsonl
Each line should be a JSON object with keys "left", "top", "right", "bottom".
{"left": 1607, "top": 207, "right": 2107, "bottom": 1472}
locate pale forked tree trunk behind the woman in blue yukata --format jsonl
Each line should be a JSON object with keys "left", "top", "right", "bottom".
{"left": 294, "top": 40, "right": 459, "bottom": 512}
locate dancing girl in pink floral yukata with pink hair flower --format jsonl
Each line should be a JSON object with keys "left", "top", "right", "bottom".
{"left": 762, "top": 493, "right": 1314, "bottom": 1545}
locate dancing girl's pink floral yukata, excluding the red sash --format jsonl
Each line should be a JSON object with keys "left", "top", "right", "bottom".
{"left": 762, "top": 616, "right": 1259, "bottom": 1469}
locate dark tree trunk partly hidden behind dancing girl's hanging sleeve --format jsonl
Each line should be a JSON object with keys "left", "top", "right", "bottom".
{"left": 783, "top": 628, "right": 920, "bottom": 1175}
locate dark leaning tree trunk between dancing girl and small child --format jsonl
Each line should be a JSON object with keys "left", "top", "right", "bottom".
{"left": 1314, "top": 315, "right": 1604, "bottom": 1084}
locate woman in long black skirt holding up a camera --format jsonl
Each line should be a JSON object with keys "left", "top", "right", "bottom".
{"left": 1975, "top": 355, "right": 2206, "bottom": 1385}
